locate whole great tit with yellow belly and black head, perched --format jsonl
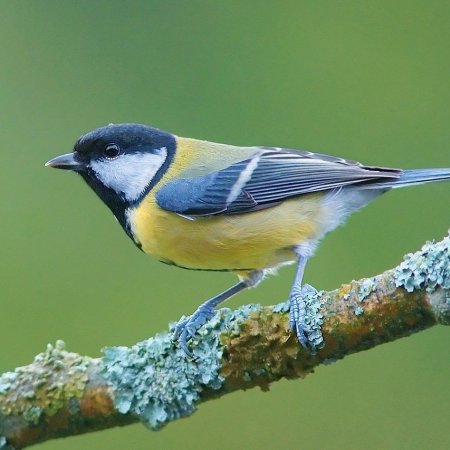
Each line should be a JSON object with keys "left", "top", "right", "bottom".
{"left": 46, "top": 123, "right": 450, "bottom": 354}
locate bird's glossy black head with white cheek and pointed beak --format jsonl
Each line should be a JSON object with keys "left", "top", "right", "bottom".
{"left": 46, "top": 124, "right": 176, "bottom": 216}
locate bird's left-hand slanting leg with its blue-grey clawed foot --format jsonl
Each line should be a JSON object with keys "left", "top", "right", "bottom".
{"left": 174, "top": 271, "right": 263, "bottom": 356}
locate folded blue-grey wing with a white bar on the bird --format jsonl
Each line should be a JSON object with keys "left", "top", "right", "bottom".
{"left": 156, "top": 147, "right": 401, "bottom": 216}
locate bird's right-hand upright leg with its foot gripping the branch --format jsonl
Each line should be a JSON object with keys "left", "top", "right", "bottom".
{"left": 289, "top": 255, "right": 317, "bottom": 354}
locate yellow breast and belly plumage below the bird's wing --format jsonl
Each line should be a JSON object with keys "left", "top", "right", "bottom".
{"left": 127, "top": 196, "right": 321, "bottom": 270}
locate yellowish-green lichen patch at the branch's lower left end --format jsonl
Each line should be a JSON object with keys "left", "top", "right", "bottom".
{"left": 0, "top": 341, "right": 90, "bottom": 424}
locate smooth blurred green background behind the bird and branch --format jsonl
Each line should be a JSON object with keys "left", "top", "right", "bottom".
{"left": 0, "top": 0, "right": 450, "bottom": 450}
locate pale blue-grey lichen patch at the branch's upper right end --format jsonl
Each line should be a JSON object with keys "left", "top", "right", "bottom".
{"left": 394, "top": 235, "right": 450, "bottom": 292}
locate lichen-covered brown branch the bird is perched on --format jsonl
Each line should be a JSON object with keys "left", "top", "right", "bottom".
{"left": 0, "top": 236, "right": 450, "bottom": 449}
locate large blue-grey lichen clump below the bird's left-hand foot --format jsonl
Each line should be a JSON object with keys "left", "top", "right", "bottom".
{"left": 103, "top": 311, "right": 229, "bottom": 430}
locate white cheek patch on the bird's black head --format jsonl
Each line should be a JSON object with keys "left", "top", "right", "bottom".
{"left": 89, "top": 147, "right": 167, "bottom": 201}
